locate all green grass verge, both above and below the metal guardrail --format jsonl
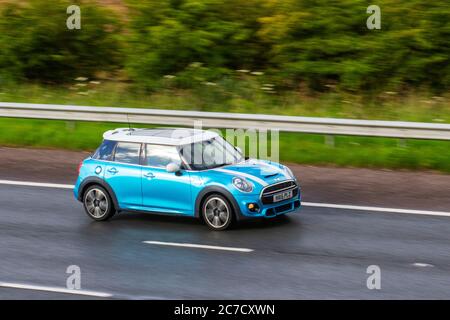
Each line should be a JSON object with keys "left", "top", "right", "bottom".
{"left": 0, "top": 80, "right": 450, "bottom": 172}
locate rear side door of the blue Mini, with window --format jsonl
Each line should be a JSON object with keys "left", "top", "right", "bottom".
{"left": 104, "top": 142, "right": 142, "bottom": 209}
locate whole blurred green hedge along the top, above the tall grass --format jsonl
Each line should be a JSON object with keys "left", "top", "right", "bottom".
{"left": 0, "top": 0, "right": 450, "bottom": 93}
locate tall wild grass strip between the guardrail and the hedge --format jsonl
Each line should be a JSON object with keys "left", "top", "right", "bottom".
{"left": 0, "top": 80, "right": 450, "bottom": 123}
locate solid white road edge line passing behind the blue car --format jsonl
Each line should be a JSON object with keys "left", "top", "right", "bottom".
{"left": 0, "top": 179, "right": 450, "bottom": 217}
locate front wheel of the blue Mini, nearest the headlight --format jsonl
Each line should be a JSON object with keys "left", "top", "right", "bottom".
{"left": 202, "top": 194, "right": 234, "bottom": 231}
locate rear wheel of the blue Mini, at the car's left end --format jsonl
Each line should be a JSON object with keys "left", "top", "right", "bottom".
{"left": 83, "top": 185, "right": 116, "bottom": 221}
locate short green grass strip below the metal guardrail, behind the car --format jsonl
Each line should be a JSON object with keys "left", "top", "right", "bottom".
{"left": 0, "top": 118, "right": 450, "bottom": 173}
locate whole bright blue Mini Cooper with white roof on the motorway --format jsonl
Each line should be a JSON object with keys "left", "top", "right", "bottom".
{"left": 74, "top": 128, "right": 300, "bottom": 230}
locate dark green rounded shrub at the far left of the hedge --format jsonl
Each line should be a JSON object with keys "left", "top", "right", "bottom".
{"left": 0, "top": 0, "right": 122, "bottom": 83}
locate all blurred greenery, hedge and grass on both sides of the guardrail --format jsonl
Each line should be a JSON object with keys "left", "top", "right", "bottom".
{"left": 0, "top": 0, "right": 450, "bottom": 172}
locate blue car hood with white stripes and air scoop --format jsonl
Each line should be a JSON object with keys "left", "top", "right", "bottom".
{"left": 214, "top": 159, "right": 293, "bottom": 187}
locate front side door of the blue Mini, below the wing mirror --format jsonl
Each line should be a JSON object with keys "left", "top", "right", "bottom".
{"left": 142, "top": 144, "right": 194, "bottom": 215}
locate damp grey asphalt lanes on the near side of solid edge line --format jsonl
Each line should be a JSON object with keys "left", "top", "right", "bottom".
{"left": 0, "top": 185, "right": 450, "bottom": 299}
